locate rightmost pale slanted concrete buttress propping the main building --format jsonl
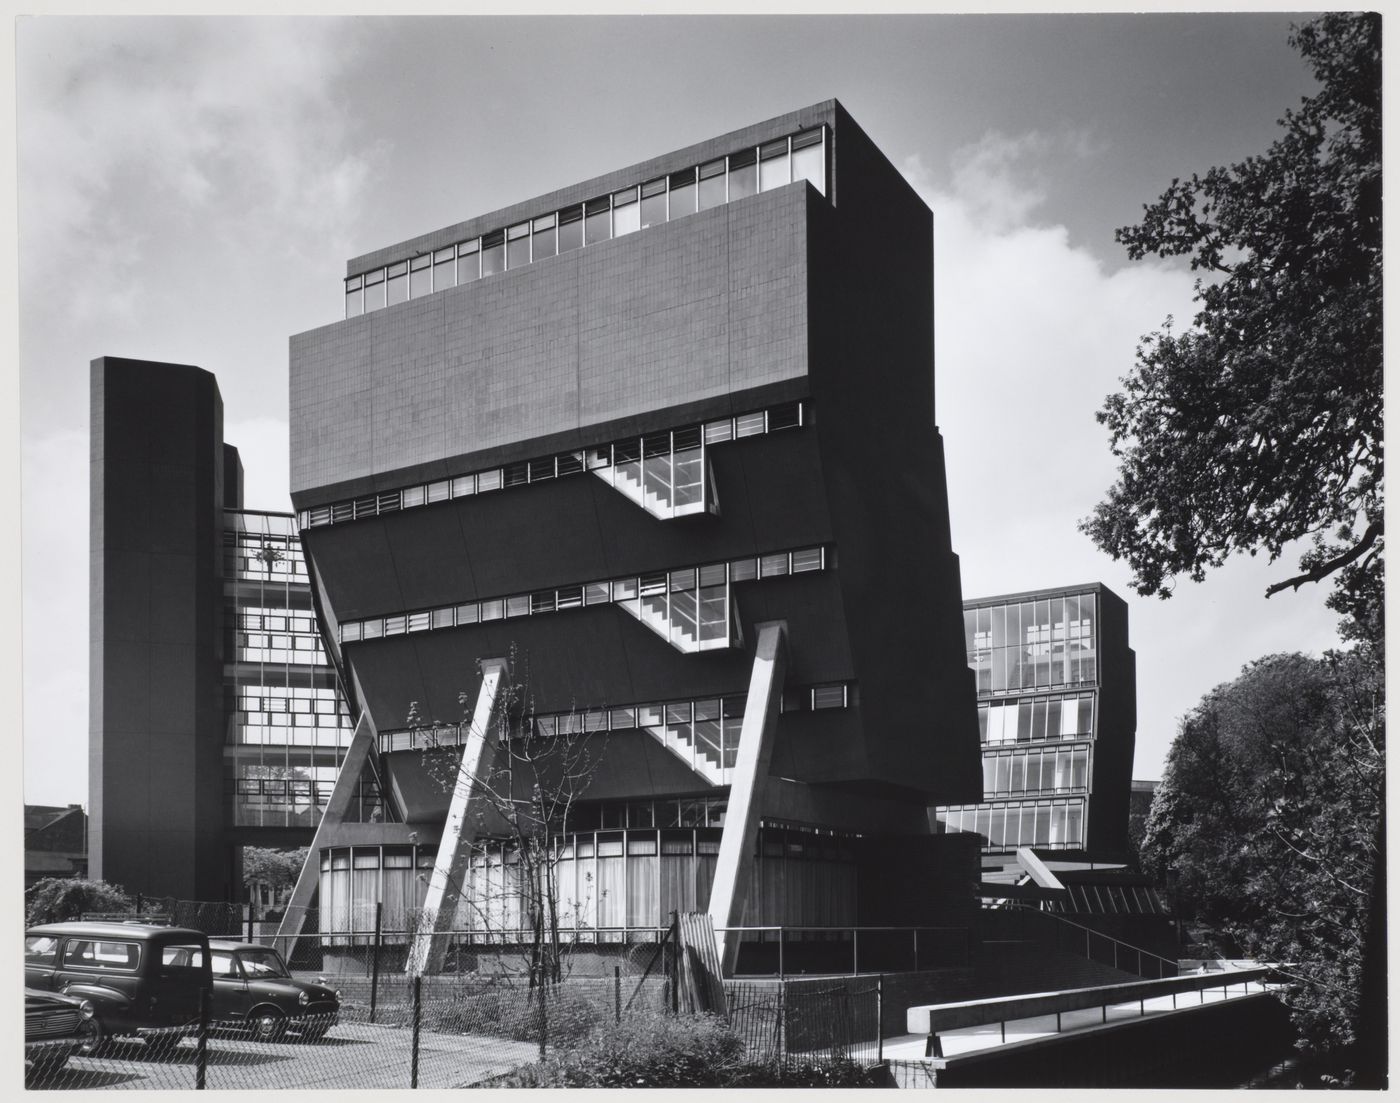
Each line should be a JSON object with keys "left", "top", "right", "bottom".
{"left": 710, "top": 620, "right": 787, "bottom": 977}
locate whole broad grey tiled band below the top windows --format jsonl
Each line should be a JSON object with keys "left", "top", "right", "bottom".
{"left": 291, "top": 183, "right": 825, "bottom": 494}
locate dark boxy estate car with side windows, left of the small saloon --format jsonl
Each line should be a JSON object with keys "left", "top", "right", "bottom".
{"left": 24, "top": 921, "right": 213, "bottom": 1047}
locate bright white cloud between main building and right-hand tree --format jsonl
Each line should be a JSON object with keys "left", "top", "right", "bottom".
{"left": 904, "top": 134, "right": 1336, "bottom": 777}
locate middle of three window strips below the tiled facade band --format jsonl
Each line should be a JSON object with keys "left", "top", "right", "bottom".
{"left": 340, "top": 547, "right": 834, "bottom": 644}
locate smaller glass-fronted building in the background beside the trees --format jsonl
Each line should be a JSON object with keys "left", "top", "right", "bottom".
{"left": 934, "top": 584, "right": 1137, "bottom": 869}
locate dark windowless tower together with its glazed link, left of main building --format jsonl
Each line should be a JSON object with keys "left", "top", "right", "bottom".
{"left": 88, "top": 357, "right": 349, "bottom": 900}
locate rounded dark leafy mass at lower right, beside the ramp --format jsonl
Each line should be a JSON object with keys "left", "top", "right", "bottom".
{"left": 1142, "top": 647, "right": 1385, "bottom": 1053}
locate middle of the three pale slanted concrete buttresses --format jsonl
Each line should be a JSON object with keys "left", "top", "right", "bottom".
{"left": 403, "top": 659, "right": 505, "bottom": 976}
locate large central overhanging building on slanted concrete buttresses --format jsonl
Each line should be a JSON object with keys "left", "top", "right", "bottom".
{"left": 284, "top": 101, "right": 981, "bottom": 952}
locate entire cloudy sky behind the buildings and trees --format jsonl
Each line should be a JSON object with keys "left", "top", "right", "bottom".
{"left": 17, "top": 14, "right": 1336, "bottom": 803}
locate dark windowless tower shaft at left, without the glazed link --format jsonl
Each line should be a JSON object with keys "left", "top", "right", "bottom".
{"left": 90, "top": 357, "right": 228, "bottom": 900}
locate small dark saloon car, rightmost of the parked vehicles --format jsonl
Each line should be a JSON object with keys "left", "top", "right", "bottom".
{"left": 209, "top": 939, "right": 340, "bottom": 1041}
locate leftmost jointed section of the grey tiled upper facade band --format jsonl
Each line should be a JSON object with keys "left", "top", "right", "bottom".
{"left": 290, "top": 315, "right": 378, "bottom": 487}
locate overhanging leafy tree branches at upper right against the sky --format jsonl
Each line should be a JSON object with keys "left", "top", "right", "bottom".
{"left": 1081, "top": 13, "right": 1385, "bottom": 642}
